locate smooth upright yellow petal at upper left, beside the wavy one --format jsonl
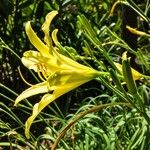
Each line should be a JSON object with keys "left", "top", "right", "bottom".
{"left": 25, "top": 21, "right": 49, "bottom": 56}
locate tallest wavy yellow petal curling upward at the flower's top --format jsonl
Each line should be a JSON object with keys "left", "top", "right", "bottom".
{"left": 42, "top": 11, "right": 58, "bottom": 50}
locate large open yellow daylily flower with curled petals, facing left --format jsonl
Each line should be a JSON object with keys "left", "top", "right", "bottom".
{"left": 15, "top": 11, "right": 106, "bottom": 138}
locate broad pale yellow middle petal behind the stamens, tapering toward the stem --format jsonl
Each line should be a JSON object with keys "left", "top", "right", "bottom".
{"left": 22, "top": 50, "right": 96, "bottom": 74}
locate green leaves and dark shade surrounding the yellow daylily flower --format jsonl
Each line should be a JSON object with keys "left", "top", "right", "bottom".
{"left": 0, "top": 0, "right": 150, "bottom": 150}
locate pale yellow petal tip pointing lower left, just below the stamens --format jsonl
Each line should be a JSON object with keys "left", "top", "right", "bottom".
{"left": 14, "top": 82, "right": 49, "bottom": 106}
